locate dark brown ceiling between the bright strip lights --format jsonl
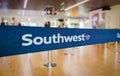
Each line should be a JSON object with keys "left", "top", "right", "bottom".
{"left": 0, "top": 0, "right": 120, "bottom": 11}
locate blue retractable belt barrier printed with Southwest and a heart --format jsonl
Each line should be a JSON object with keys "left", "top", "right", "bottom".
{"left": 0, "top": 26, "right": 120, "bottom": 57}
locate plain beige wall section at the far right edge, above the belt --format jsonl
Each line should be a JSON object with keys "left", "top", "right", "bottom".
{"left": 105, "top": 4, "right": 120, "bottom": 29}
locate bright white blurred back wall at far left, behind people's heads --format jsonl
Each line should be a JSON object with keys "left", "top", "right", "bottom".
{"left": 0, "top": 9, "right": 44, "bottom": 26}
